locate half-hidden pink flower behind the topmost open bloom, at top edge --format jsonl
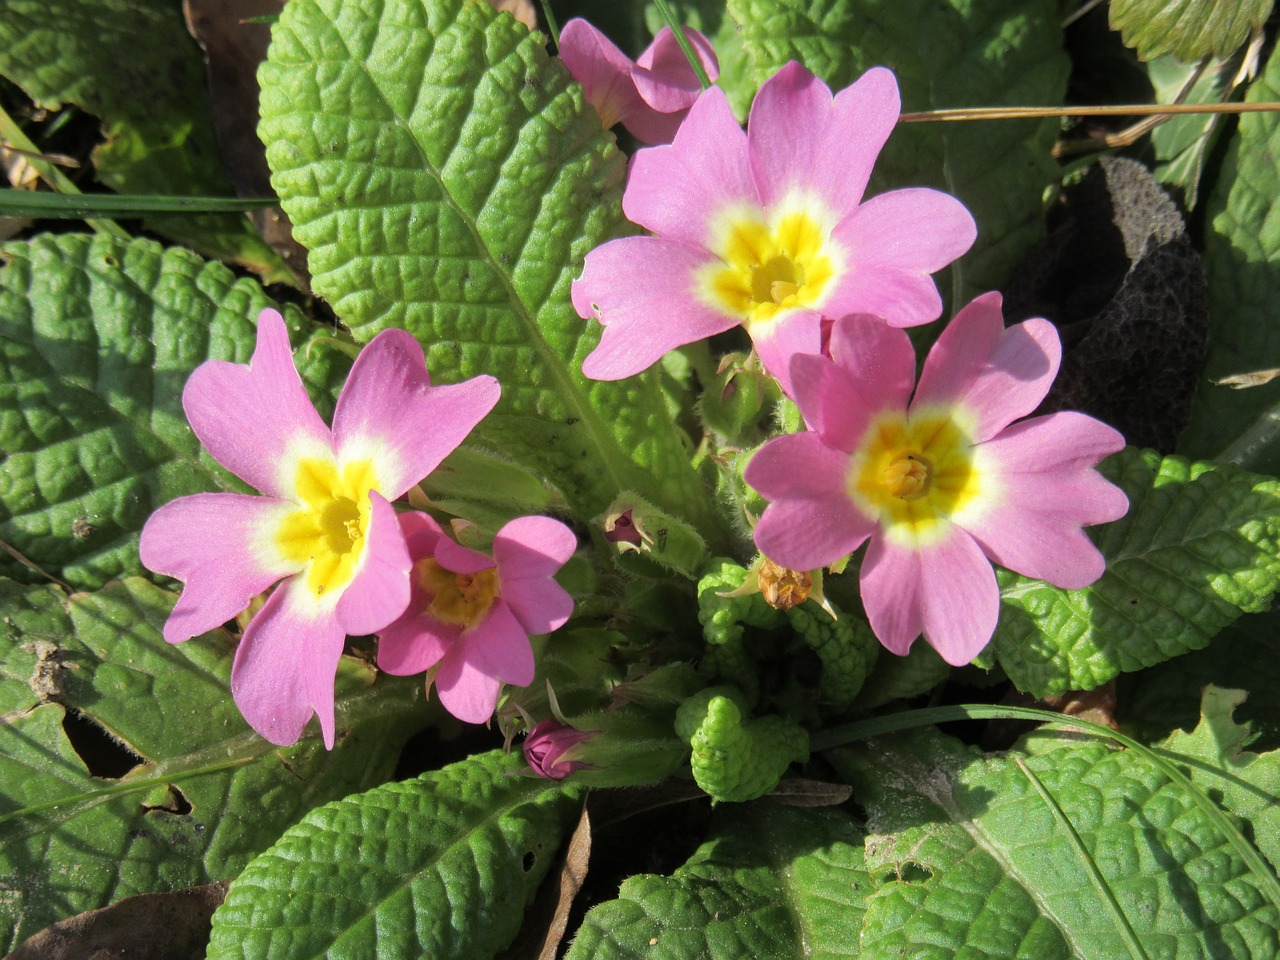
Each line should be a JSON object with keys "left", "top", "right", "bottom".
{"left": 559, "top": 18, "right": 719, "bottom": 143}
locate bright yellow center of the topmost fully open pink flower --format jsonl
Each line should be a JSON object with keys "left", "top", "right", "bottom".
{"left": 700, "top": 204, "right": 844, "bottom": 326}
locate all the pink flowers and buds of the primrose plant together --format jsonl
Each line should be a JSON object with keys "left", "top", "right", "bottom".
{"left": 141, "top": 20, "right": 1128, "bottom": 780}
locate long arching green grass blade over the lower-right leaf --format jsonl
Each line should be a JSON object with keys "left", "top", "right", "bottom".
{"left": 809, "top": 704, "right": 1280, "bottom": 910}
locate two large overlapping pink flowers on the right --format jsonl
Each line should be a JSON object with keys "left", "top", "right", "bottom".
{"left": 572, "top": 43, "right": 1128, "bottom": 664}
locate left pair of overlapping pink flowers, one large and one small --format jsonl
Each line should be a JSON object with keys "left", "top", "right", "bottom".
{"left": 141, "top": 310, "right": 573, "bottom": 748}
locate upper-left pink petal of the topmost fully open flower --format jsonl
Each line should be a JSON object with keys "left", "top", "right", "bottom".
{"left": 622, "top": 87, "right": 759, "bottom": 244}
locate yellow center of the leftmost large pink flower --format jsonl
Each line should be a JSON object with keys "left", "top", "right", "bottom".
{"left": 275, "top": 458, "right": 378, "bottom": 599}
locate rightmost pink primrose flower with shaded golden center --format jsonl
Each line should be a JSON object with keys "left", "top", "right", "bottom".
{"left": 745, "top": 293, "right": 1129, "bottom": 666}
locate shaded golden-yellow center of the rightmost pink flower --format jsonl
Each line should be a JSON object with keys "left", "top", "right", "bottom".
{"left": 847, "top": 411, "right": 982, "bottom": 545}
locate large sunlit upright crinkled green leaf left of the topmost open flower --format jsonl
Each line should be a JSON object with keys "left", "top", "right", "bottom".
{"left": 260, "top": 0, "right": 722, "bottom": 539}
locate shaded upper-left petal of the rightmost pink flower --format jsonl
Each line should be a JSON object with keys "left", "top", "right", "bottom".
{"left": 791, "top": 315, "right": 915, "bottom": 453}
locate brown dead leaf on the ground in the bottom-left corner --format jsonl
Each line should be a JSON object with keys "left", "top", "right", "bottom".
{"left": 5, "top": 883, "right": 227, "bottom": 960}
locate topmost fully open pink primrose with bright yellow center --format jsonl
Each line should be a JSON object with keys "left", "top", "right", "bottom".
{"left": 572, "top": 63, "right": 975, "bottom": 392}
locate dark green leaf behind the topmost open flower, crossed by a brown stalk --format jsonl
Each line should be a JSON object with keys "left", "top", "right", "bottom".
{"left": 728, "top": 0, "right": 1069, "bottom": 307}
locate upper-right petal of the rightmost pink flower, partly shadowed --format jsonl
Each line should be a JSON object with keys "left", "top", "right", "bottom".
{"left": 911, "top": 293, "right": 1062, "bottom": 442}
